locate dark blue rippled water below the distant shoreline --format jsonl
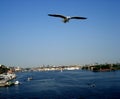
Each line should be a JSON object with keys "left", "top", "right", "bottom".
{"left": 0, "top": 70, "right": 120, "bottom": 99}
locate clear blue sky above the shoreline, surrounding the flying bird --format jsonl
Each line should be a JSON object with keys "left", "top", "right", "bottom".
{"left": 0, "top": 0, "right": 120, "bottom": 67}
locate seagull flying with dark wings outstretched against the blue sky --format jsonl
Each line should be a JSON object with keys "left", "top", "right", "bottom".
{"left": 48, "top": 14, "right": 87, "bottom": 23}
